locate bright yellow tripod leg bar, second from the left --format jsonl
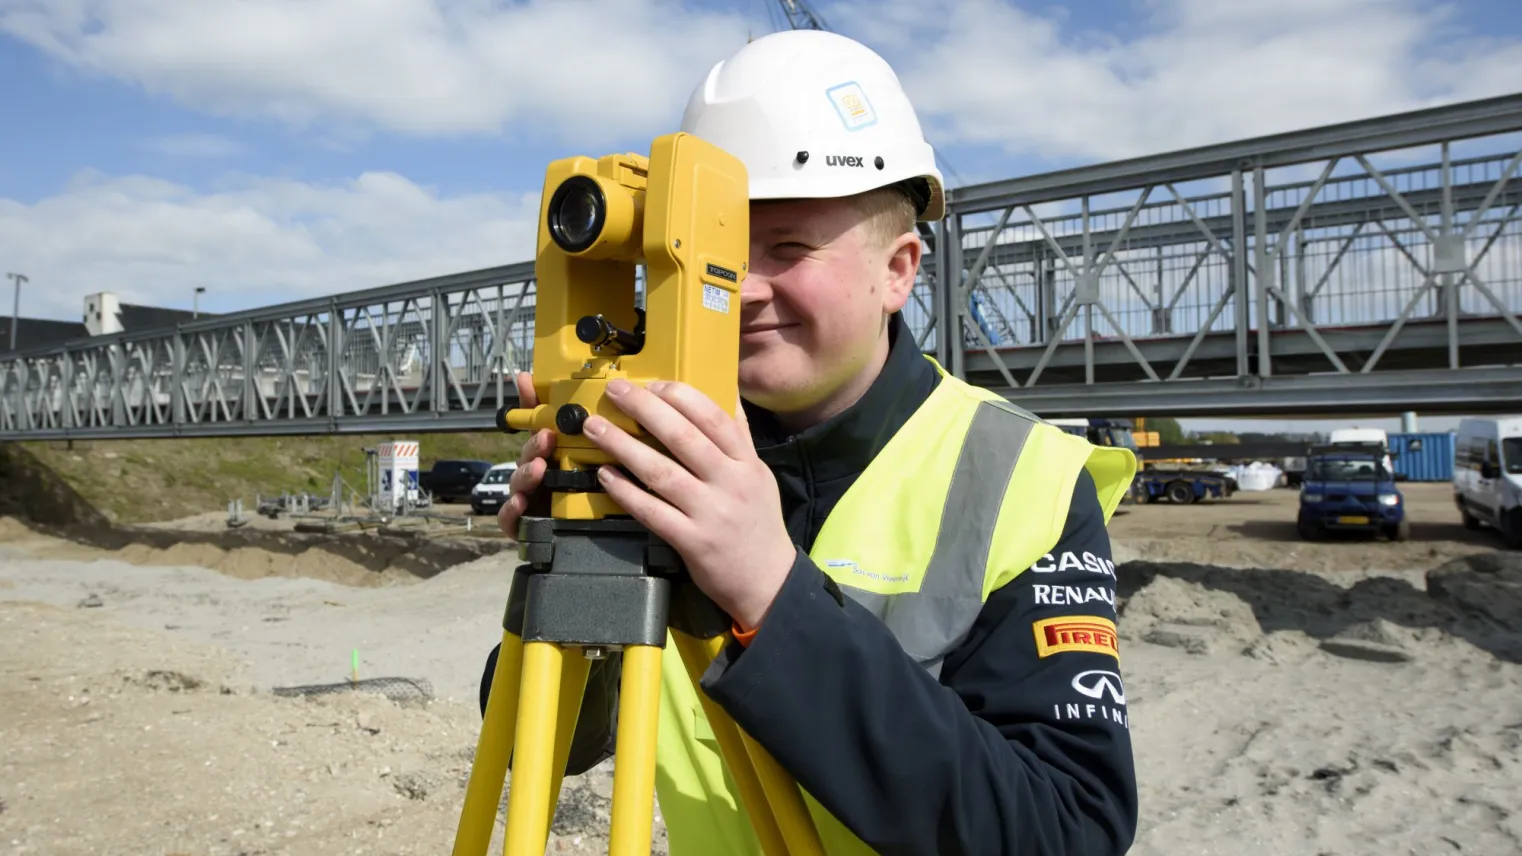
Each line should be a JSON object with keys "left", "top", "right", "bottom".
{"left": 504, "top": 641, "right": 566, "bottom": 856}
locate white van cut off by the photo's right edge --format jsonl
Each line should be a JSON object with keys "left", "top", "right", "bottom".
{"left": 1454, "top": 416, "right": 1522, "bottom": 550}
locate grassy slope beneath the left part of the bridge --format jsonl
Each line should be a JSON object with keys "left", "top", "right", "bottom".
{"left": 15, "top": 431, "right": 524, "bottom": 524}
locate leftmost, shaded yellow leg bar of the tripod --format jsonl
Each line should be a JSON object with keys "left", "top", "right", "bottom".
{"left": 454, "top": 631, "right": 524, "bottom": 856}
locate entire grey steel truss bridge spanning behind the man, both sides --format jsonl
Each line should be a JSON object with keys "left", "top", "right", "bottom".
{"left": 0, "top": 94, "right": 1522, "bottom": 440}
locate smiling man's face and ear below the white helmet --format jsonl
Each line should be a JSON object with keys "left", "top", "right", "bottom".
{"left": 740, "top": 200, "right": 921, "bottom": 416}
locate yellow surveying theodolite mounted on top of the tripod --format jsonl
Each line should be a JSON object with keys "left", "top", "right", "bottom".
{"left": 496, "top": 133, "right": 750, "bottom": 519}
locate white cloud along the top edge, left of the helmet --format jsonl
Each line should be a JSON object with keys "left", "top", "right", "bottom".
{"left": 0, "top": 0, "right": 747, "bottom": 145}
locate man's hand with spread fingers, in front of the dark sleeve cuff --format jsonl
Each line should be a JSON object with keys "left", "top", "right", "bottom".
{"left": 581, "top": 381, "right": 796, "bottom": 629}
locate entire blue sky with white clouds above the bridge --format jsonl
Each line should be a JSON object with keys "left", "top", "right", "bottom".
{"left": 0, "top": 0, "right": 1522, "bottom": 429}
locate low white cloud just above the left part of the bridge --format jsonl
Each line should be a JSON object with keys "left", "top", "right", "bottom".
{"left": 0, "top": 172, "right": 539, "bottom": 318}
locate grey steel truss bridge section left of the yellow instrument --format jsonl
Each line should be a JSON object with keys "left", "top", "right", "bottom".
{"left": 0, "top": 264, "right": 534, "bottom": 437}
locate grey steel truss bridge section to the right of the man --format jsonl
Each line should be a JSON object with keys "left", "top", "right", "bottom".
{"left": 936, "top": 96, "right": 1522, "bottom": 414}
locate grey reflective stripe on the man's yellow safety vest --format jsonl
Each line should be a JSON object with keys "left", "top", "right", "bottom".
{"left": 842, "top": 402, "right": 1035, "bottom": 676}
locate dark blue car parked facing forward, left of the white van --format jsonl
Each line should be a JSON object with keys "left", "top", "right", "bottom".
{"left": 1297, "top": 445, "right": 1411, "bottom": 541}
